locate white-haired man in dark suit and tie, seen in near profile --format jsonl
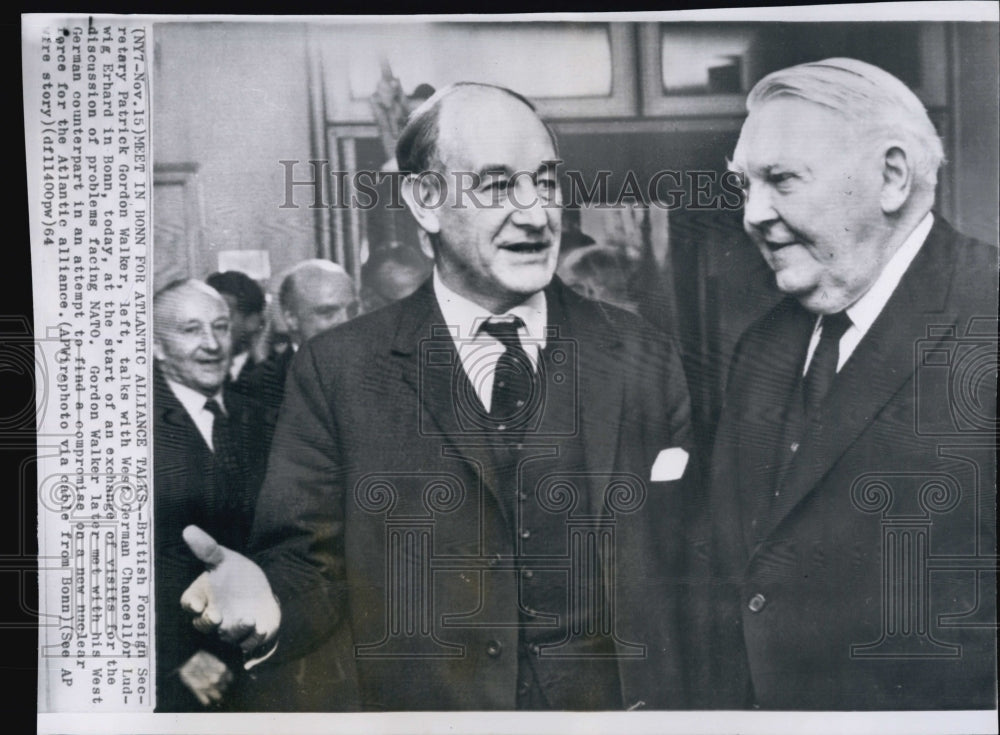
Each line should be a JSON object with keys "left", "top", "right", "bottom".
{"left": 694, "top": 59, "right": 997, "bottom": 710}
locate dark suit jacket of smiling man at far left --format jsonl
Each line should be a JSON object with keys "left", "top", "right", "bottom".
{"left": 153, "top": 366, "right": 263, "bottom": 712}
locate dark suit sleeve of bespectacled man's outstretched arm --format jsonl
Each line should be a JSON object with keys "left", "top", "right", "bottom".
{"left": 251, "top": 346, "right": 347, "bottom": 660}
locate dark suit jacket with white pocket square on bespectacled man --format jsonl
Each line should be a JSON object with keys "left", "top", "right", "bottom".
{"left": 254, "top": 281, "right": 694, "bottom": 710}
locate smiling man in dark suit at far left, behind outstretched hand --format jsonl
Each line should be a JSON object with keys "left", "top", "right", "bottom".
{"left": 153, "top": 280, "right": 263, "bottom": 712}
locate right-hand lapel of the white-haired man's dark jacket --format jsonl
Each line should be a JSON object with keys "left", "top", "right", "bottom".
{"left": 765, "top": 219, "right": 955, "bottom": 535}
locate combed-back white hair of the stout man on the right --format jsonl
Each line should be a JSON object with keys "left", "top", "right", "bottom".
{"left": 747, "top": 58, "right": 944, "bottom": 192}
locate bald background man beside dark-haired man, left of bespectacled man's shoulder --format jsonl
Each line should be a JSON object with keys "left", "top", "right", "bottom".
{"left": 249, "top": 259, "right": 358, "bottom": 448}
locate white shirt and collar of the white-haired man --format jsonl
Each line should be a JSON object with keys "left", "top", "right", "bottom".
{"left": 802, "top": 212, "right": 934, "bottom": 375}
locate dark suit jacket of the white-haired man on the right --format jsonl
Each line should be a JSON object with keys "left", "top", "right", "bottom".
{"left": 691, "top": 218, "right": 997, "bottom": 710}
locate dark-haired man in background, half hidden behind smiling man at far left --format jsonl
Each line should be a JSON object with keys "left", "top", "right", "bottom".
{"left": 205, "top": 271, "right": 266, "bottom": 395}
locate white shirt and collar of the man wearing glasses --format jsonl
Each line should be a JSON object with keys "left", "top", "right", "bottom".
{"left": 434, "top": 268, "right": 548, "bottom": 412}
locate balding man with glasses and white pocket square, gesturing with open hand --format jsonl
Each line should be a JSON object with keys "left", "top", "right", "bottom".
{"left": 178, "top": 84, "right": 694, "bottom": 710}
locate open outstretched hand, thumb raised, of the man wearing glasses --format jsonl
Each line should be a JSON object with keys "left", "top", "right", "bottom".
{"left": 181, "top": 526, "right": 281, "bottom": 656}
